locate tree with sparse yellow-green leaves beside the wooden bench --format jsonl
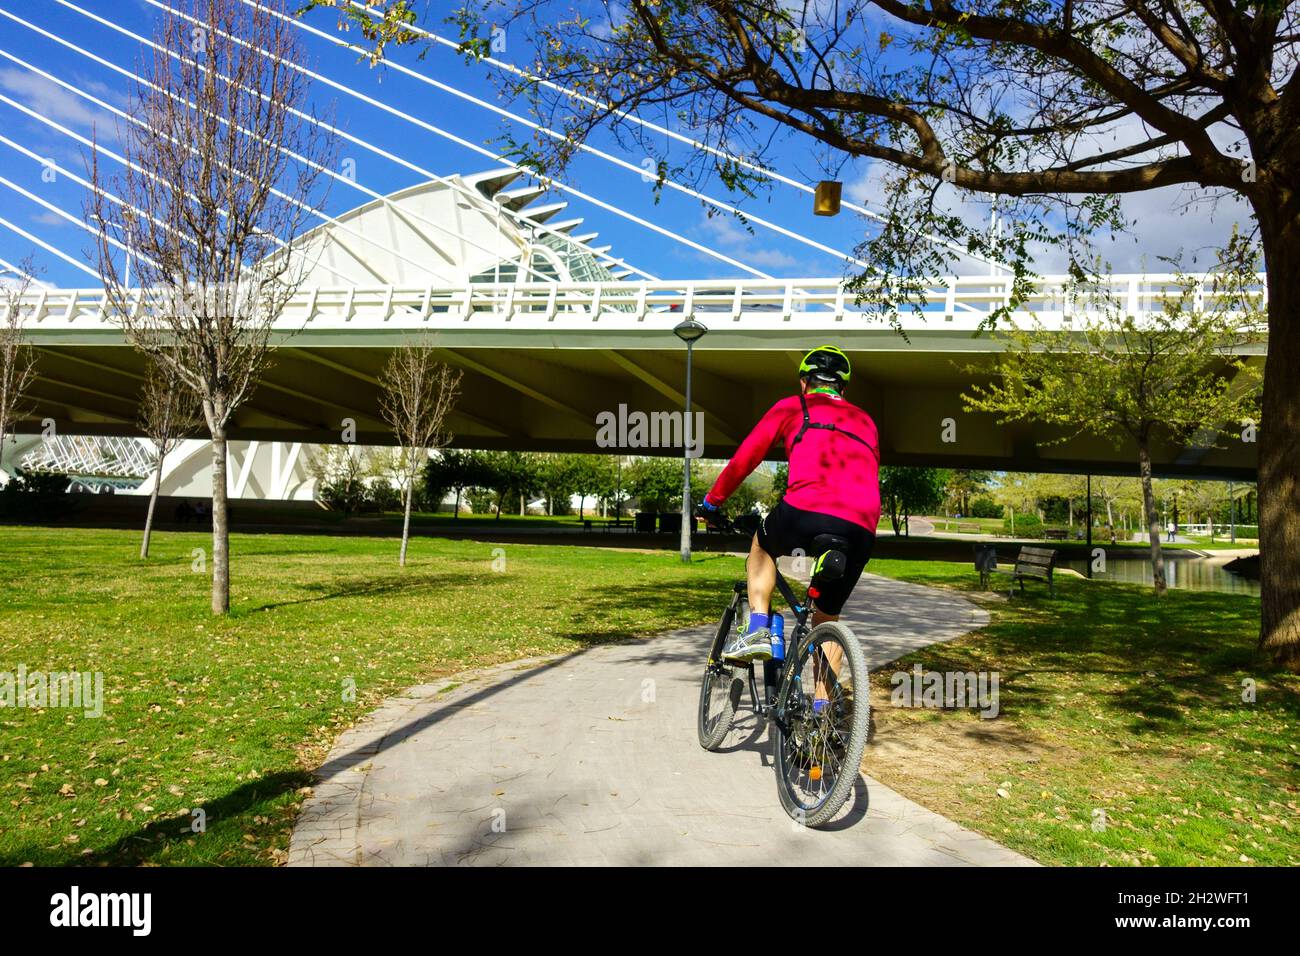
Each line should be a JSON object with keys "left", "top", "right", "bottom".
{"left": 962, "top": 273, "right": 1260, "bottom": 594}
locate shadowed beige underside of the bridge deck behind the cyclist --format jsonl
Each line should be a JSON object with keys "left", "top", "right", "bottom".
{"left": 18, "top": 325, "right": 1262, "bottom": 479}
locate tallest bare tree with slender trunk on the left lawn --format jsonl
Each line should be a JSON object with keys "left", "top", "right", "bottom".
{"left": 87, "top": 0, "right": 330, "bottom": 614}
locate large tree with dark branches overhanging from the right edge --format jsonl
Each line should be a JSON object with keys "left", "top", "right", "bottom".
{"left": 311, "top": 0, "right": 1300, "bottom": 665}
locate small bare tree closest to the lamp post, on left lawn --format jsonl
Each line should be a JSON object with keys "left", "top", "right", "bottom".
{"left": 380, "top": 342, "right": 460, "bottom": 567}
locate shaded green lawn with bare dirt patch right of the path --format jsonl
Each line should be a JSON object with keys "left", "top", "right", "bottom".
{"left": 865, "top": 561, "right": 1300, "bottom": 865}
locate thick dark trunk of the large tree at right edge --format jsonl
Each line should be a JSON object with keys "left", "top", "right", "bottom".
{"left": 1255, "top": 201, "right": 1300, "bottom": 670}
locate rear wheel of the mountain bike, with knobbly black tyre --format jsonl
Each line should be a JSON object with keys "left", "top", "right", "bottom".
{"left": 772, "top": 622, "right": 871, "bottom": 827}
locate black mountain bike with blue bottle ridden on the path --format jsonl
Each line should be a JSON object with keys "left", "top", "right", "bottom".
{"left": 698, "top": 522, "right": 871, "bottom": 827}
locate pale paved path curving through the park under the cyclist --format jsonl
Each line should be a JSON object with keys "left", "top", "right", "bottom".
{"left": 290, "top": 575, "right": 1030, "bottom": 866}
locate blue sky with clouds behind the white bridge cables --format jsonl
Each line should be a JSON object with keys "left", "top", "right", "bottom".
{"left": 0, "top": 0, "right": 1240, "bottom": 286}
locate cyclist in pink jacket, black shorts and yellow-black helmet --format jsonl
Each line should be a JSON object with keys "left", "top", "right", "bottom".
{"left": 699, "top": 345, "right": 880, "bottom": 676}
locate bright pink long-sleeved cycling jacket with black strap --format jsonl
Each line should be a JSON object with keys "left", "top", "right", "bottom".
{"left": 707, "top": 392, "right": 880, "bottom": 533}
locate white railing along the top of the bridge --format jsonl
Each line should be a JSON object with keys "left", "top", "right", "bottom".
{"left": 12, "top": 274, "right": 1266, "bottom": 330}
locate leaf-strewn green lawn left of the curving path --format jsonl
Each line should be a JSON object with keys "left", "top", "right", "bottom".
{"left": 0, "top": 527, "right": 741, "bottom": 865}
